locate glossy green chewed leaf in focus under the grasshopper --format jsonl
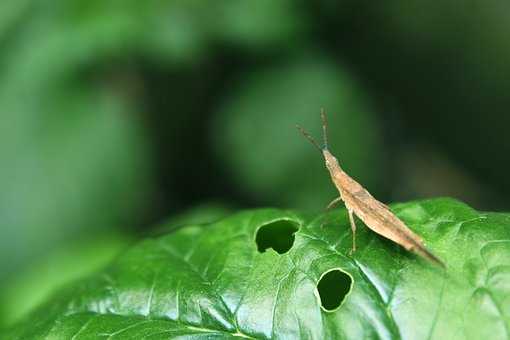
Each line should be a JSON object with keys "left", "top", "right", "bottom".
{"left": 6, "top": 199, "right": 510, "bottom": 339}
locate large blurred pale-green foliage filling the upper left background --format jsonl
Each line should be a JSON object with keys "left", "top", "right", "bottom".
{"left": 0, "top": 0, "right": 300, "bottom": 279}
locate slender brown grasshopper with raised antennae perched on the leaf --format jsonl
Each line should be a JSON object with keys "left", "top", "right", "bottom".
{"left": 297, "top": 110, "right": 445, "bottom": 268}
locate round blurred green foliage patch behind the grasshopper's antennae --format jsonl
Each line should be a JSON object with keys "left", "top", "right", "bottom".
{"left": 213, "top": 55, "right": 384, "bottom": 209}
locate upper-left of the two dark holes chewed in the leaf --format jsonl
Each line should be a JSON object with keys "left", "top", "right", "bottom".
{"left": 255, "top": 221, "right": 298, "bottom": 254}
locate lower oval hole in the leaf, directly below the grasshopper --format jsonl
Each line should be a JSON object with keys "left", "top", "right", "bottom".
{"left": 317, "top": 269, "right": 352, "bottom": 312}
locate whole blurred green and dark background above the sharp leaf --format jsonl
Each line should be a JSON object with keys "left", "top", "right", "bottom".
{"left": 0, "top": 0, "right": 510, "bottom": 326}
